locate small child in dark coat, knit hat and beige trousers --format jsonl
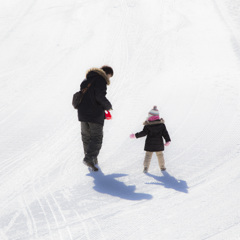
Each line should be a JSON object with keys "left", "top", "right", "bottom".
{"left": 130, "top": 106, "right": 171, "bottom": 173}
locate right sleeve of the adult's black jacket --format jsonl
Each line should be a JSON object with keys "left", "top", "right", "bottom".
{"left": 95, "top": 79, "right": 112, "bottom": 110}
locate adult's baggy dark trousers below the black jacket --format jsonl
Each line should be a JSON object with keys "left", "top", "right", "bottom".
{"left": 81, "top": 122, "right": 103, "bottom": 162}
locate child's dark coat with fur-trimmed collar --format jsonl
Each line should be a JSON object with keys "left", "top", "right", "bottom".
{"left": 135, "top": 119, "right": 171, "bottom": 152}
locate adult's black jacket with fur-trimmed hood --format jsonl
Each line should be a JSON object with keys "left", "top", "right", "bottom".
{"left": 78, "top": 68, "right": 112, "bottom": 125}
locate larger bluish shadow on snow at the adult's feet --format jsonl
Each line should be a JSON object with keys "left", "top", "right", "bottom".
{"left": 87, "top": 168, "right": 152, "bottom": 201}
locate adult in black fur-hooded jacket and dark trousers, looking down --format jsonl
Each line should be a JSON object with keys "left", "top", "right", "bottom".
{"left": 78, "top": 66, "right": 113, "bottom": 167}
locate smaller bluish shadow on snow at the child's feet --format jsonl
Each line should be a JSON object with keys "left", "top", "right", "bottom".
{"left": 146, "top": 171, "right": 188, "bottom": 193}
